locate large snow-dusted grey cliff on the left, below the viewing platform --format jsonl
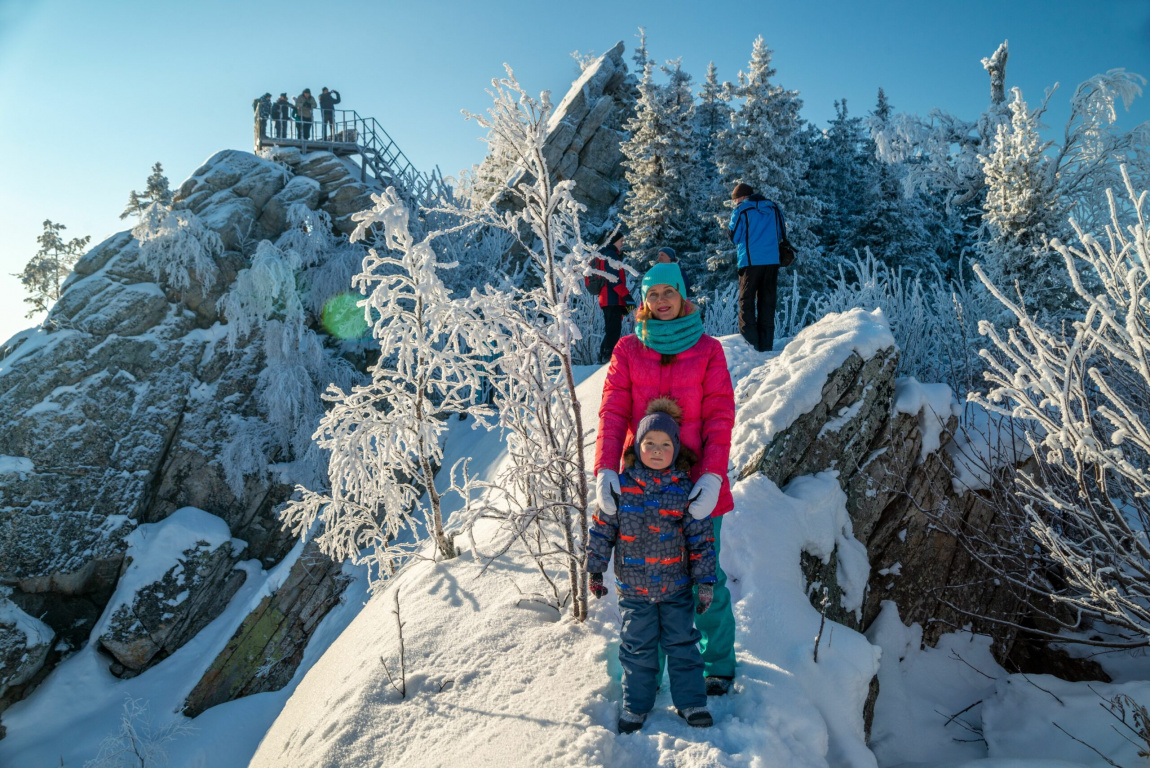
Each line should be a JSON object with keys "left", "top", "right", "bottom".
{"left": 0, "top": 151, "right": 369, "bottom": 711}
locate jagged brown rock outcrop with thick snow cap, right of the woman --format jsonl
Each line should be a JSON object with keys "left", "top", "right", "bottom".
{"left": 735, "top": 310, "right": 1020, "bottom": 658}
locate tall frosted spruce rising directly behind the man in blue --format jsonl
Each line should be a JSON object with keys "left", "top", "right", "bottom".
{"left": 715, "top": 37, "right": 826, "bottom": 285}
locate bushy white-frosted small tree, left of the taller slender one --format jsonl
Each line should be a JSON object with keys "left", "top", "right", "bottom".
{"left": 281, "top": 187, "right": 485, "bottom": 583}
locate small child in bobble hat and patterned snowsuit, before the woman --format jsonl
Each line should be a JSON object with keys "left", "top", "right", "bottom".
{"left": 587, "top": 398, "right": 715, "bottom": 734}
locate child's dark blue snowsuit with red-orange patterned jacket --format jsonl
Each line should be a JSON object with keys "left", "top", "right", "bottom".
{"left": 587, "top": 464, "right": 715, "bottom": 714}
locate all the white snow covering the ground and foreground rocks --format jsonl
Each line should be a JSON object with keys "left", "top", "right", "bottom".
{"left": 0, "top": 310, "right": 1150, "bottom": 768}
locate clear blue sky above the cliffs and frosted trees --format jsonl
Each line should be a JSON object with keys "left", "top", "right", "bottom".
{"left": 0, "top": 0, "right": 1150, "bottom": 341}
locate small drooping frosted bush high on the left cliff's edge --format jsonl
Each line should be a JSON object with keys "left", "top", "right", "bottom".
{"left": 132, "top": 202, "right": 223, "bottom": 292}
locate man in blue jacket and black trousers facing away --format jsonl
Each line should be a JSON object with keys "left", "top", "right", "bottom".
{"left": 727, "top": 183, "right": 787, "bottom": 352}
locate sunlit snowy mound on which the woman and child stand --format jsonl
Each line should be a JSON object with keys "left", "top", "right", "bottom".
{"left": 252, "top": 337, "right": 879, "bottom": 767}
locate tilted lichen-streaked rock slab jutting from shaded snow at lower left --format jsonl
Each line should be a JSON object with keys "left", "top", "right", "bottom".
{"left": 184, "top": 543, "right": 345, "bottom": 717}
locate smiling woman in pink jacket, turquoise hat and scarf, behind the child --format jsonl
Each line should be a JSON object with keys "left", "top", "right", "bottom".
{"left": 595, "top": 263, "right": 735, "bottom": 696}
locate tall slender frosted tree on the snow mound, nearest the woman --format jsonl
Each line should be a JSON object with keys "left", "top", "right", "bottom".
{"left": 460, "top": 68, "right": 596, "bottom": 621}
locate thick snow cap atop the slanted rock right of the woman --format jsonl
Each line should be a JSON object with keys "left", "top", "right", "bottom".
{"left": 730, "top": 309, "right": 895, "bottom": 471}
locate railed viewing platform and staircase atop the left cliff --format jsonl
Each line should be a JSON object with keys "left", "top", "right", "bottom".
{"left": 254, "top": 109, "right": 453, "bottom": 206}
